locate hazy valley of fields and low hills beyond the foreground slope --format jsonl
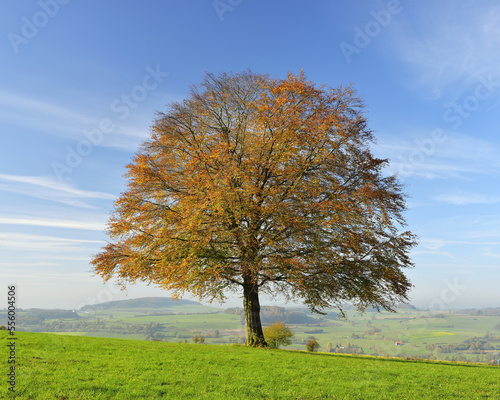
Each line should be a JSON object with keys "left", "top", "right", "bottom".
{"left": 0, "top": 297, "right": 500, "bottom": 364}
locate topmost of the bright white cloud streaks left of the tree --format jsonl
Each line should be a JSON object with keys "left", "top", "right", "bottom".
{"left": 0, "top": 174, "right": 116, "bottom": 208}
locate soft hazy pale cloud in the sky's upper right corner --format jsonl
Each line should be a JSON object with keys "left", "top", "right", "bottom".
{"left": 392, "top": 0, "right": 500, "bottom": 98}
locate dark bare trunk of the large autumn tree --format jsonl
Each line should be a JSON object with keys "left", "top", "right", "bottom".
{"left": 243, "top": 278, "right": 267, "bottom": 347}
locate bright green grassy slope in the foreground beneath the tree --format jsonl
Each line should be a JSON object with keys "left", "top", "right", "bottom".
{"left": 0, "top": 331, "right": 500, "bottom": 400}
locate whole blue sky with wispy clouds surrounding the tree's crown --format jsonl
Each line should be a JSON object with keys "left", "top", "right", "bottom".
{"left": 0, "top": 0, "right": 500, "bottom": 309}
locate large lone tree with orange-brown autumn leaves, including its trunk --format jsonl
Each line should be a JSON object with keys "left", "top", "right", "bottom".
{"left": 92, "top": 72, "right": 416, "bottom": 346}
